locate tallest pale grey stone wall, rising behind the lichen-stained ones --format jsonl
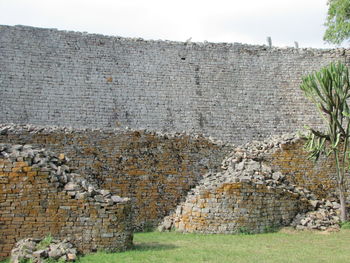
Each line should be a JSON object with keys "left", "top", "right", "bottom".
{"left": 0, "top": 26, "right": 350, "bottom": 144}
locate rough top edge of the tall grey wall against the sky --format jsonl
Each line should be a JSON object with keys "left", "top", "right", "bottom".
{"left": 0, "top": 25, "right": 344, "bottom": 53}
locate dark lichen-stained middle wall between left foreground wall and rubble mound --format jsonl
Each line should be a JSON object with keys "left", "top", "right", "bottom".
{"left": 0, "top": 125, "right": 230, "bottom": 229}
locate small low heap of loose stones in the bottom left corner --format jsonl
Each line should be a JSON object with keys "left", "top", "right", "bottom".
{"left": 11, "top": 238, "right": 77, "bottom": 263}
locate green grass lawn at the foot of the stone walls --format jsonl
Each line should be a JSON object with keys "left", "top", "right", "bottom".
{"left": 2, "top": 229, "right": 350, "bottom": 263}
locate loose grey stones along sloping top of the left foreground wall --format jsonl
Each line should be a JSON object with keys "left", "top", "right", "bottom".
{"left": 0, "top": 143, "right": 129, "bottom": 204}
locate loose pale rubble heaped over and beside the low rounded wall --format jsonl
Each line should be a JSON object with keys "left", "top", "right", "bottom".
{"left": 158, "top": 134, "right": 340, "bottom": 231}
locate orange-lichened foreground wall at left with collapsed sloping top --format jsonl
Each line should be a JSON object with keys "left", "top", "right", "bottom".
{"left": 0, "top": 144, "right": 132, "bottom": 258}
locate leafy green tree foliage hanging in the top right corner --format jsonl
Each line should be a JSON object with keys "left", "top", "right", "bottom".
{"left": 323, "top": 0, "right": 350, "bottom": 44}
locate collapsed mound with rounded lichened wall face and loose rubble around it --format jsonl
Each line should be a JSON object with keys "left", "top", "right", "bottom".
{"left": 159, "top": 135, "right": 339, "bottom": 233}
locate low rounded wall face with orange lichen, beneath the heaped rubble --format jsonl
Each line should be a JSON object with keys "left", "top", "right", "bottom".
{"left": 174, "top": 182, "right": 308, "bottom": 234}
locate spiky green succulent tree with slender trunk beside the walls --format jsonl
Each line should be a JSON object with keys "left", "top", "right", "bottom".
{"left": 300, "top": 62, "right": 350, "bottom": 222}
